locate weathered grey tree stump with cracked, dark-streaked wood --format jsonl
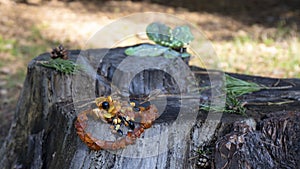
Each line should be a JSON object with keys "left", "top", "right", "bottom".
{"left": 0, "top": 45, "right": 300, "bottom": 169}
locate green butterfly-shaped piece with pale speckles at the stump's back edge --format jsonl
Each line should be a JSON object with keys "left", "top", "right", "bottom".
{"left": 125, "top": 22, "right": 194, "bottom": 58}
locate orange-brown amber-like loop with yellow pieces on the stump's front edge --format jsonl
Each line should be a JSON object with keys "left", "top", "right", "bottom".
{"left": 75, "top": 96, "right": 158, "bottom": 151}
